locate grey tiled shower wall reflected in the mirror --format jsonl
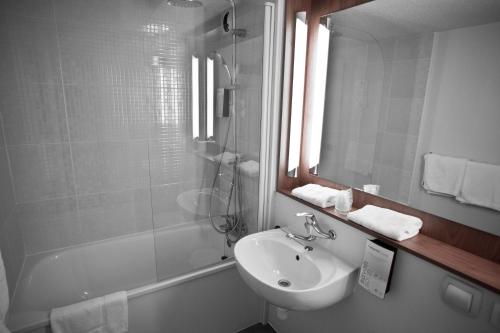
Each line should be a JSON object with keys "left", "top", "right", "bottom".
{"left": 319, "top": 34, "right": 433, "bottom": 203}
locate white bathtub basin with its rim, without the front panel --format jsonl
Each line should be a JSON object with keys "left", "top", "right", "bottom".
{"left": 8, "top": 221, "right": 254, "bottom": 332}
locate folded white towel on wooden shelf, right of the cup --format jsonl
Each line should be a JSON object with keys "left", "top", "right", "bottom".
{"left": 347, "top": 205, "right": 422, "bottom": 241}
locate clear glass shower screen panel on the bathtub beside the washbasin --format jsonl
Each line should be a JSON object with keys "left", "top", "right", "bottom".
{"left": 145, "top": 1, "right": 264, "bottom": 279}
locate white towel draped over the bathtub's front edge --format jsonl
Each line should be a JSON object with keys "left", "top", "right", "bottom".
{"left": 50, "top": 291, "right": 128, "bottom": 333}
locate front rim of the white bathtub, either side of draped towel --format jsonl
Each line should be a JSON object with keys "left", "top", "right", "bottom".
{"left": 9, "top": 257, "right": 236, "bottom": 333}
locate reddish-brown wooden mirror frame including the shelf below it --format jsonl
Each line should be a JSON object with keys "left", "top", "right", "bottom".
{"left": 277, "top": 0, "right": 500, "bottom": 293}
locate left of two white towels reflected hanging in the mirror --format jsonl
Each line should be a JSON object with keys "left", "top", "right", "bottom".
{"left": 422, "top": 153, "right": 467, "bottom": 197}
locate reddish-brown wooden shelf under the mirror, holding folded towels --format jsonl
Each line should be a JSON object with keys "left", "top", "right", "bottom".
{"left": 278, "top": 190, "right": 500, "bottom": 294}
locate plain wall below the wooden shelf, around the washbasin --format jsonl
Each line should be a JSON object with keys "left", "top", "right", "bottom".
{"left": 269, "top": 194, "right": 500, "bottom": 333}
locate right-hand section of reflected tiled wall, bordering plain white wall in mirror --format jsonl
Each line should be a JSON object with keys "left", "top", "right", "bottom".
{"left": 373, "top": 33, "right": 434, "bottom": 203}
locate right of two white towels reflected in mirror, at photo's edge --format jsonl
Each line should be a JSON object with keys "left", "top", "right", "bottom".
{"left": 457, "top": 161, "right": 500, "bottom": 211}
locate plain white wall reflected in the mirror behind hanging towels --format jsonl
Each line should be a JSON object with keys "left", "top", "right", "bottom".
{"left": 410, "top": 22, "right": 500, "bottom": 235}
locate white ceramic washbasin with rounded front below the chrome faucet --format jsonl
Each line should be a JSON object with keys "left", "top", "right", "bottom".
{"left": 234, "top": 229, "right": 357, "bottom": 311}
